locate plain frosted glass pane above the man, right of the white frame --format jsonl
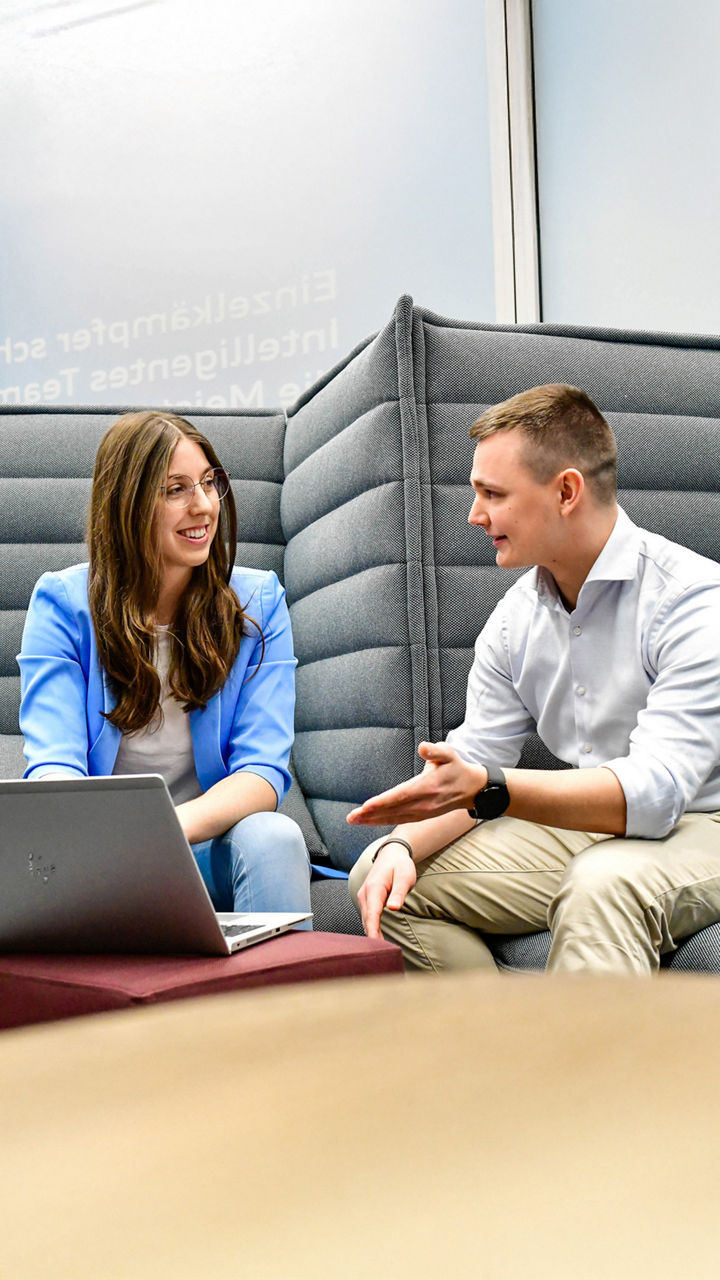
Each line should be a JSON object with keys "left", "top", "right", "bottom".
{"left": 533, "top": 0, "right": 720, "bottom": 333}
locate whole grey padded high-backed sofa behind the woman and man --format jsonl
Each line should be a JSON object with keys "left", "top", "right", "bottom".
{"left": 0, "top": 297, "right": 720, "bottom": 973}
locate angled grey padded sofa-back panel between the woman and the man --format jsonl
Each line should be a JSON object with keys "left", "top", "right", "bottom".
{"left": 281, "top": 300, "right": 428, "bottom": 869}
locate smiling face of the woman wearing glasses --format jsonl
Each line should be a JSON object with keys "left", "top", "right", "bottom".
{"left": 155, "top": 436, "right": 220, "bottom": 585}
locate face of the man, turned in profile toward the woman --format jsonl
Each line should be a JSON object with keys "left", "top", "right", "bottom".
{"left": 468, "top": 430, "right": 565, "bottom": 572}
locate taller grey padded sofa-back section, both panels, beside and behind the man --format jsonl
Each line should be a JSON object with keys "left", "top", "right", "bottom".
{"left": 281, "top": 298, "right": 720, "bottom": 868}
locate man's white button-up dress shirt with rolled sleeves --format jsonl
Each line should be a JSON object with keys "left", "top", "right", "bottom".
{"left": 447, "top": 511, "right": 720, "bottom": 840}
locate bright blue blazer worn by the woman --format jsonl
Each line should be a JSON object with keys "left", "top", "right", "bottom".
{"left": 18, "top": 564, "right": 296, "bottom": 804}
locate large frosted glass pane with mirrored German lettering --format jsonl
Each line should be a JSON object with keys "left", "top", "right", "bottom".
{"left": 0, "top": 0, "right": 495, "bottom": 407}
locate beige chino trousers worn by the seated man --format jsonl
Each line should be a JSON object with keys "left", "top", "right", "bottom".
{"left": 350, "top": 813, "right": 720, "bottom": 974}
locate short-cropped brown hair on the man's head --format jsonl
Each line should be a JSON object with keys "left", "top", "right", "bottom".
{"left": 470, "top": 383, "right": 618, "bottom": 504}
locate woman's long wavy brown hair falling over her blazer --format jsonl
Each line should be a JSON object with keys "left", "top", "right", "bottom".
{"left": 87, "top": 412, "right": 245, "bottom": 733}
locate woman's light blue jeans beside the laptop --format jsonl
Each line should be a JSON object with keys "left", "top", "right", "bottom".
{"left": 192, "top": 813, "right": 313, "bottom": 929}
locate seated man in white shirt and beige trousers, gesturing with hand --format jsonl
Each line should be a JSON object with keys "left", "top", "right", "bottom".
{"left": 348, "top": 385, "right": 720, "bottom": 973}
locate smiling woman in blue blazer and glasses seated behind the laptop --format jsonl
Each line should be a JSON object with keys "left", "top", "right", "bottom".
{"left": 18, "top": 412, "right": 310, "bottom": 911}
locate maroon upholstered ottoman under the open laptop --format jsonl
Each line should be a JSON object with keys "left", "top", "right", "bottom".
{"left": 0, "top": 929, "right": 402, "bottom": 1028}
